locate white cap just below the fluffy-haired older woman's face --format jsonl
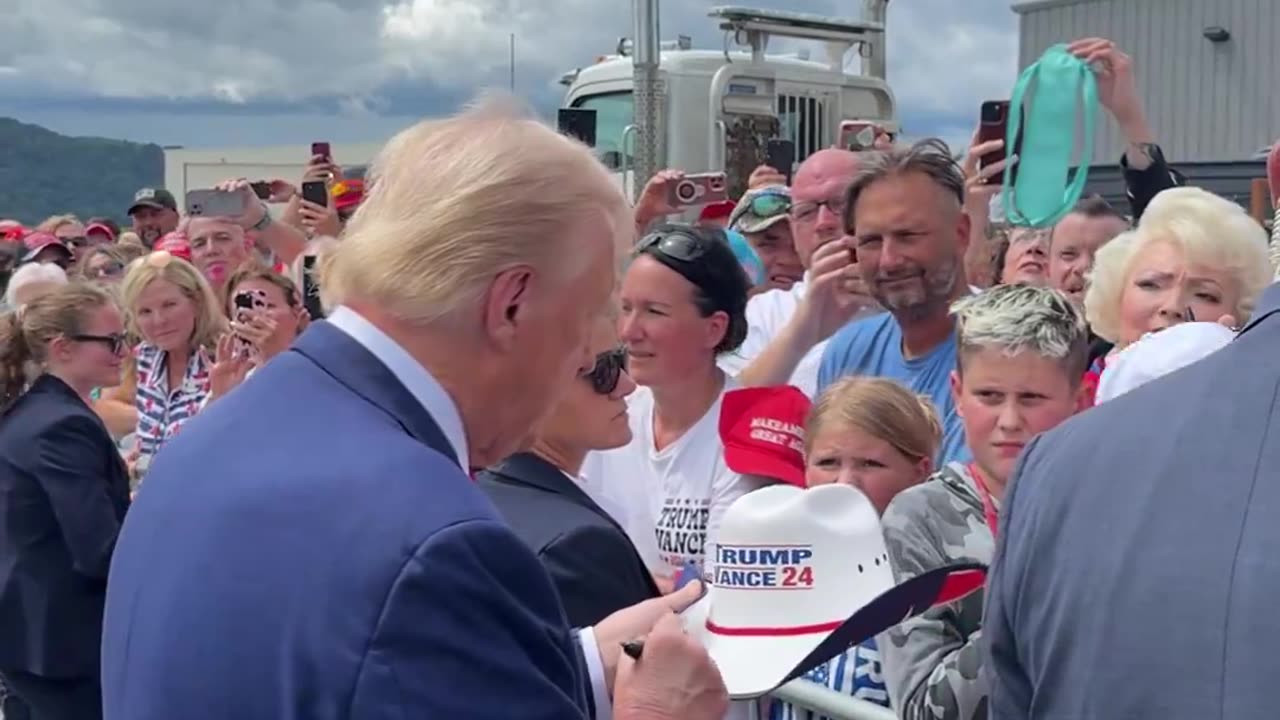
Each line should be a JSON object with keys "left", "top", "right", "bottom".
{"left": 1094, "top": 323, "right": 1236, "bottom": 402}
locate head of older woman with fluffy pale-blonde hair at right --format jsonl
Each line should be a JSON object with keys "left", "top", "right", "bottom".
{"left": 1084, "top": 187, "right": 1271, "bottom": 394}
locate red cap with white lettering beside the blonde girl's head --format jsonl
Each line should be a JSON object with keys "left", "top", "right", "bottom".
{"left": 719, "top": 386, "right": 813, "bottom": 488}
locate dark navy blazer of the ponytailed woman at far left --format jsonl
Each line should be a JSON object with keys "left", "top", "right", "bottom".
{"left": 0, "top": 374, "right": 129, "bottom": 720}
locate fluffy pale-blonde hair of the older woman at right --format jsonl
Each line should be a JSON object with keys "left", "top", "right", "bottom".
{"left": 1084, "top": 187, "right": 1271, "bottom": 342}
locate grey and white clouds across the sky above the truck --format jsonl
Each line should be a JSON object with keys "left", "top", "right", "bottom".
{"left": 0, "top": 0, "right": 1016, "bottom": 128}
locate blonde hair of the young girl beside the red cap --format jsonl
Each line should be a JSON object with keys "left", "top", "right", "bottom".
{"left": 804, "top": 375, "right": 942, "bottom": 461}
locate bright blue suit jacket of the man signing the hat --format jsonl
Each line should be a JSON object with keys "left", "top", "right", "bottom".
{"left": 102, "top": 323, "right": 590, "bottom": 720}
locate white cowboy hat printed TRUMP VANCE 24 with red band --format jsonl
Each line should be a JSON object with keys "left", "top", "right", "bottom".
{"left": 681, "top": 484, "right": 987, "bottom": 700}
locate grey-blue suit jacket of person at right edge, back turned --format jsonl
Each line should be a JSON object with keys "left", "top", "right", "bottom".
{"left": 982, "top": 286, "right": 1280, "bottom": 720}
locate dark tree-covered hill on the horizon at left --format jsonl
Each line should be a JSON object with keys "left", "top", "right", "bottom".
{"left": 0, "top": 118, "right": 164, "bottom": 224}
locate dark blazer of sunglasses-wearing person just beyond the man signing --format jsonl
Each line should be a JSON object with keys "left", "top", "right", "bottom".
{"left": 476, "top": 452, "right": 659, "bottom": 628}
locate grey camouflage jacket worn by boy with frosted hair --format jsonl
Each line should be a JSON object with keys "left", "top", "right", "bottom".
{"left": 879, "top": 464, "right": 995, "bottom": 720}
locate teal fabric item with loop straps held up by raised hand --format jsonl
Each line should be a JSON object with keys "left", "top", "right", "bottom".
{"left": 1001, "top": 45, "right": 1098, "bottom": 228}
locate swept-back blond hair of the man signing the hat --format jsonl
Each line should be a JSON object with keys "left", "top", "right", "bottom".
{"left": 319, "top": 92, "right": 634, "bottom": 324}
